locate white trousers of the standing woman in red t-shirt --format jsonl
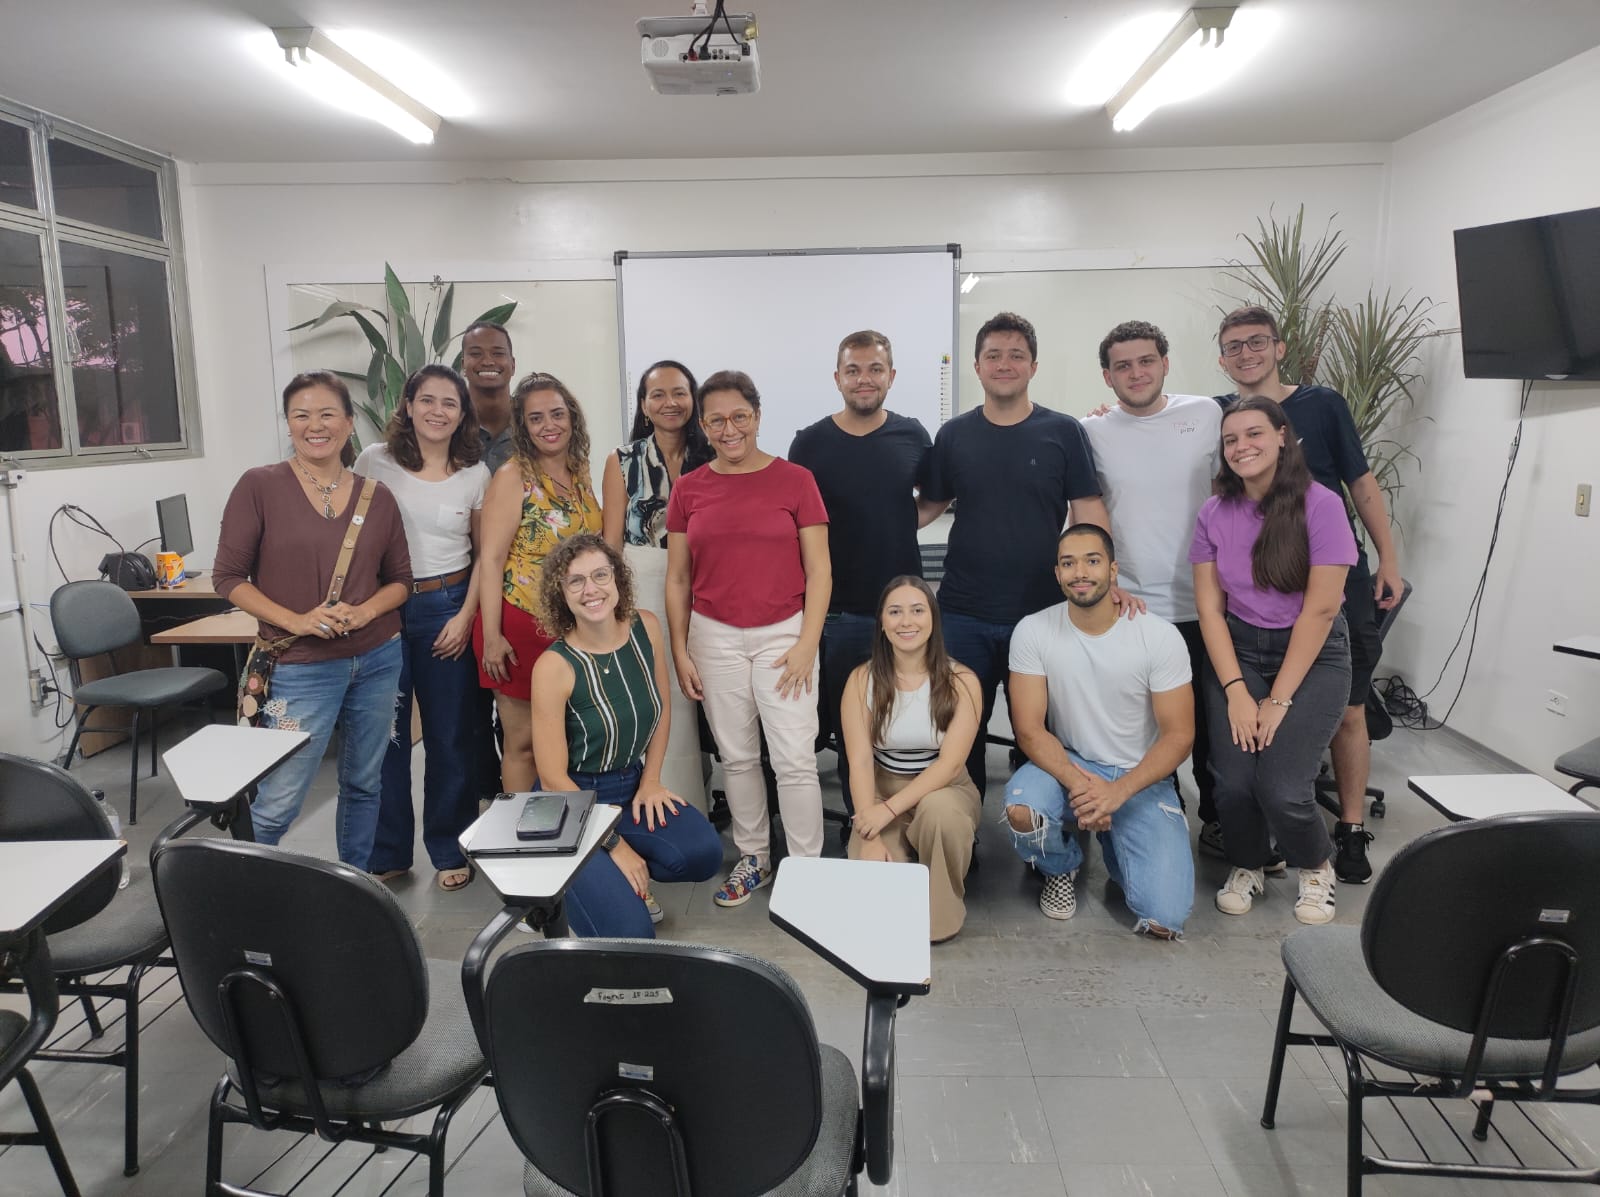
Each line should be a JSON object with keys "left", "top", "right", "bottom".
{"left": 690, "top": 611, "right": 822, "bottom": 861}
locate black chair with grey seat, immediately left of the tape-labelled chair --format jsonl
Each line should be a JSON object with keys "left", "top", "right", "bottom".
{"left": 152, "top": 839, "right": 485, "bottom": 1197}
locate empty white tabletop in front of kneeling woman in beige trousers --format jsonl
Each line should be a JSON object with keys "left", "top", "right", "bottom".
{"left": 768, "top": 856, "right": 933, "bottom": 994}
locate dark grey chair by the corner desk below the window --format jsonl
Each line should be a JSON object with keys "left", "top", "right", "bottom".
{"left": 50, "top": 582, "right": 227, "bottom": 823}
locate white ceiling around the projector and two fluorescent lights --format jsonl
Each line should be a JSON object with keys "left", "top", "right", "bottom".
{"left": 9, "top": 0, "right": 1600, "bottom": 162}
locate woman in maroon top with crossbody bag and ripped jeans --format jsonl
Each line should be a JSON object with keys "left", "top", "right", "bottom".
{"left": 213, "top": 371, "right": 411, "bottom": 869}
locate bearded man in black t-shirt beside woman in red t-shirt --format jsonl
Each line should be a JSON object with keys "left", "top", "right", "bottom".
{"left": 789, "top": 328, "right": 931, "bottom": 813}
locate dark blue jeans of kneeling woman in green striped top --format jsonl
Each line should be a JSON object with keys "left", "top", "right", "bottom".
{"left": 566, "top": 765, "right": 722, "bottom": 939}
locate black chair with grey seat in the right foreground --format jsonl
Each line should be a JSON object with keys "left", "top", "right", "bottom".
{"left": 1261, "top": 813, "right": 1600, "bottom": 1197}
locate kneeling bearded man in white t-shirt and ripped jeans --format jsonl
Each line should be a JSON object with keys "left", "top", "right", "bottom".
{"left": 1005, "top": 523, "right": 1195, "bottom": 939}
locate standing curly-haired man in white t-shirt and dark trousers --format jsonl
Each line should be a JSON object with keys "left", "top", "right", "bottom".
{"left": 1083, "top": 320, "right": 1241, "bottom": 853}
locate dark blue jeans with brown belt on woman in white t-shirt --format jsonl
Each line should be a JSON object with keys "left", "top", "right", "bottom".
{"left": 366, "top": 581, "right": 478, "bottom": 872}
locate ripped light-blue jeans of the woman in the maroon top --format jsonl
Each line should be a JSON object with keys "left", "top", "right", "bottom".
{"left": 250, "top": 637, "right": 400, "bottom": 869}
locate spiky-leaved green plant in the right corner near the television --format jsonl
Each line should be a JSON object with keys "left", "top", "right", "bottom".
{"left": 1224, "top": 205, "right": 1435, "bottom": 520}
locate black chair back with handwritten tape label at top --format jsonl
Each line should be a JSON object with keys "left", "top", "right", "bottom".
{"left": 485, "top": 939, "right": 822, "bottom": 1197}
